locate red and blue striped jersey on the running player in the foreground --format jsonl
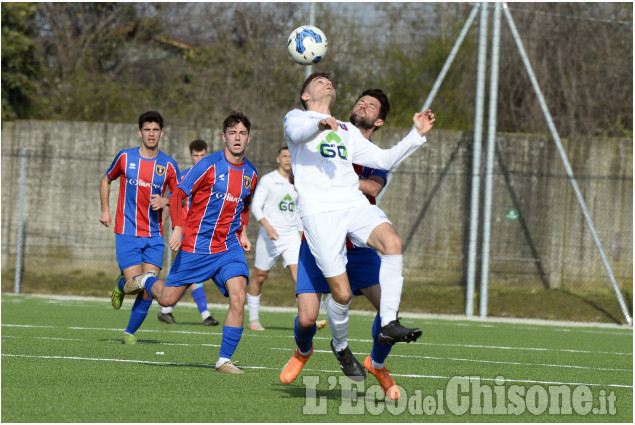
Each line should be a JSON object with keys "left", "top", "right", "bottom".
{"left": 178, "top": 151, "right": 258, "bottom": 254}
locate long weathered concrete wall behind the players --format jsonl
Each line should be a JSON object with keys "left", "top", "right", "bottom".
{"left": 2, "top": 121, "right": 633, "bottom": 288}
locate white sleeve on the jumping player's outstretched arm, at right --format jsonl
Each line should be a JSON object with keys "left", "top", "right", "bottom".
{"left": 352, "top": 129, "right": 426, "bottom": 170}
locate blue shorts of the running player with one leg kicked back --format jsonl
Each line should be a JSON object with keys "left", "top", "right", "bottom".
{"left": 165, "top": 244, "right": 249, "bottom": 297}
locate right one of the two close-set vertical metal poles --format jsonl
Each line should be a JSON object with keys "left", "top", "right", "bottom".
{"left": 478, "top": 2, "right": 501, "bottom": 317}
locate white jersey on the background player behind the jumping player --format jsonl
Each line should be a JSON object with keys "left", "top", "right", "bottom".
{"left": 251, "top": 170, "right": 302, "bottom": 233}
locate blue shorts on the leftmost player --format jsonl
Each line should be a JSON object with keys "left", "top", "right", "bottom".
{"left": 115, "top": 233, "right": 165, "bottom": 272}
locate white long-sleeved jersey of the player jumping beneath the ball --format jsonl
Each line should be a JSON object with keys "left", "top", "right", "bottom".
{"left": 284, "top": 109, "right": 426, "bottom": 217}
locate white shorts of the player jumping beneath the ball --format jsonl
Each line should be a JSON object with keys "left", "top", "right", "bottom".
{"left": 302, "top": 205, "right": 390, "bottom": 277}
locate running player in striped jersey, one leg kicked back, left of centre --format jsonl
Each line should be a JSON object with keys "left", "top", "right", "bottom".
{"left": 124, "top": 112, "right": 258, "bottom": 374}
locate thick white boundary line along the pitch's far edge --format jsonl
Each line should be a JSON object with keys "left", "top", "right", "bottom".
{"left": 2, "top": 294, "right": 633, "bottom": 333}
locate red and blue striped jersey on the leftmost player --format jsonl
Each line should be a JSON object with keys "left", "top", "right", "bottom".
{"left": 106, "top": 148, "right": 180, "bottom": 237}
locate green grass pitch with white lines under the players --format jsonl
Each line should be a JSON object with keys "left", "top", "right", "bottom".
{"left": 1, "top": 295, "right": 633, "bottom": 423}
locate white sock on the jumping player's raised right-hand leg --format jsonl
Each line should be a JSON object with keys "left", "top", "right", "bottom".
{"left": 379, "top": 255, "right": 403, "bottom": 327}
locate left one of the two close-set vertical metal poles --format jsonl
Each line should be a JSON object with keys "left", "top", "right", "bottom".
{"left": 465, "top": 2, "right": 487, "bottom": 316}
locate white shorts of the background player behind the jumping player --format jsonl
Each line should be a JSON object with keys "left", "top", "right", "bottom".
{"left": 254, "top": 226, "right": 300, "bottom": 271}
